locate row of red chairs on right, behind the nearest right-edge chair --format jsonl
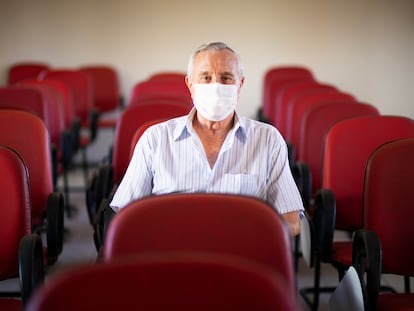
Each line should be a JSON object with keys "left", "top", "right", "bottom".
{"left": 258, "top": 67, "right": 414, "bottom": 310}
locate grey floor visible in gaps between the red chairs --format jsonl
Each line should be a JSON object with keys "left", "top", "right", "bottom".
{"left": 0, "top": 148, "right": 412, "bottom": 311}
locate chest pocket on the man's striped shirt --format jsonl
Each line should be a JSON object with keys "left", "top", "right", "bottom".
{"left": 217, "top": 174, "right": 259, "bottom": 196}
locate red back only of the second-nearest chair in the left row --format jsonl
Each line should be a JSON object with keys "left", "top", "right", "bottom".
{"left": 0, "top": 109, "right": 53, "bottom": 225}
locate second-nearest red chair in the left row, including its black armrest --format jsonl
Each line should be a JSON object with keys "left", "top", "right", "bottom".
{"left": 0, "top": 109, "right": 64, "bottom": 265}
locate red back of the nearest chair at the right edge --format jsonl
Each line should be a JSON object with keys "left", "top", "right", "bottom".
{"left": 364, "top": 137, "right": 414, "bottom": 276}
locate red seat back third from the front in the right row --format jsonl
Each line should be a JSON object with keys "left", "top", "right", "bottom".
{"left": 297, "top": 102, "right": 379, "bottom": 194}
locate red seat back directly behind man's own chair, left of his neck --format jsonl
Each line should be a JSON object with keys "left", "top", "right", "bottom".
{"left": 112, "top": 102, "right": 190, "bottom": 184}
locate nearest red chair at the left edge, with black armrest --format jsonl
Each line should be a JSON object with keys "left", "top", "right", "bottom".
{"left": 0, "top": 145, "right": 44, "bottom": 311}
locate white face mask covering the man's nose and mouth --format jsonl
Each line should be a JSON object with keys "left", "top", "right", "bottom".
{"left": 193, "top": 83, "right": 238, "bottom": 121}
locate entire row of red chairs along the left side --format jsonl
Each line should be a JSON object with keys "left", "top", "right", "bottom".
{"left": 0, "top": 63, "right": 124, "bottom": 310}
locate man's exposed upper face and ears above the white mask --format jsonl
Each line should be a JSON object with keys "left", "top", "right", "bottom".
{"left": 186, "top": 50, "right": 244, "bottom": 95}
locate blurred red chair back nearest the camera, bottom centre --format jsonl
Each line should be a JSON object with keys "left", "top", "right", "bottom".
{"left": 27, "top": 252, "right": 300, "bottom": 311}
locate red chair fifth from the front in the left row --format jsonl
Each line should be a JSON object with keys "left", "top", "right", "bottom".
{"left": 38, "top": 69, "right": 99, "bottom": 184}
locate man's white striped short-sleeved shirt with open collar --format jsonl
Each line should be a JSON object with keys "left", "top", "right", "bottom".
{"left": 110, "top": 109, "right": 303, "bottom": 214}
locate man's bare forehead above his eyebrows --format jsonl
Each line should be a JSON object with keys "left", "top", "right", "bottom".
{"left": 194, "top": 49, "right": 237, "bottom": 73}
